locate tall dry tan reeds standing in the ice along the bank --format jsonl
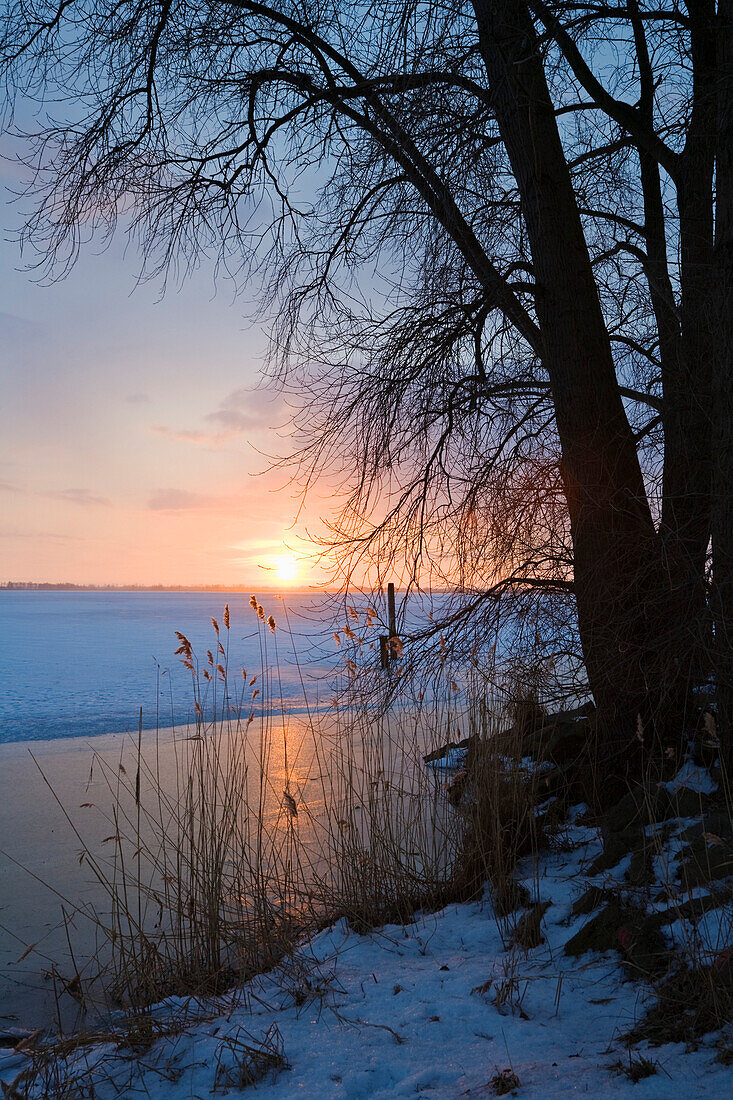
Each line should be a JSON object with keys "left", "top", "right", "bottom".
{"left": 24, "top": 597, "right": 536, "bottom": 1016}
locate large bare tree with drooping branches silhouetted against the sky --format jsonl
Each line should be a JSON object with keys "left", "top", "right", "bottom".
{"left": 0, "top": 0, "right": 730, "bottom": 774}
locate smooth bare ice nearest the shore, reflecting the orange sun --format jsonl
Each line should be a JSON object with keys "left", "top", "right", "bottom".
{"left": 0, "top": 712, "right": 451, "bottom": 1031}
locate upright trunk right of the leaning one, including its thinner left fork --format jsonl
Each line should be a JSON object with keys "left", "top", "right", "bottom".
{"left": 630, "top": 0, "right": 716, "bottom": 701}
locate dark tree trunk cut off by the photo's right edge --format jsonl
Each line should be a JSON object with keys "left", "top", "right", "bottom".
{"left": 712, "top": 0, "right": 733, "bottom": 778}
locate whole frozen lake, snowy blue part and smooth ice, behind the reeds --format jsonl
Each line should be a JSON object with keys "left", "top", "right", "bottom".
{"left": 0, "top": 591, "right": 468, "bottom": 1031}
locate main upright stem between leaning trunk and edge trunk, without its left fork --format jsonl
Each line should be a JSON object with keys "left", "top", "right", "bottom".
{"left": 649, "top": 0, "right": 716, "bottom": 695}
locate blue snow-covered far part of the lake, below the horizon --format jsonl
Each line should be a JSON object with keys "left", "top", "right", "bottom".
{"left": 0, "top": 591, "right": 346, "bottom": 743}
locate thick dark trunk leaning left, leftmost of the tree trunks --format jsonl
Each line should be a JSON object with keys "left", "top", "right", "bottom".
{"left": 473, "top": 0, "right": 672, "bottom": 765}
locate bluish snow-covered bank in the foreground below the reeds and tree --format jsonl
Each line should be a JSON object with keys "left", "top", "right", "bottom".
{"left": 0, "top": 809, "right": 733, "bottom": 1100}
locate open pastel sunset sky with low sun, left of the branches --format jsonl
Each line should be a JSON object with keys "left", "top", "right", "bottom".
{"left": 0, "top": 162, "right": 328, "bottom": 586}
